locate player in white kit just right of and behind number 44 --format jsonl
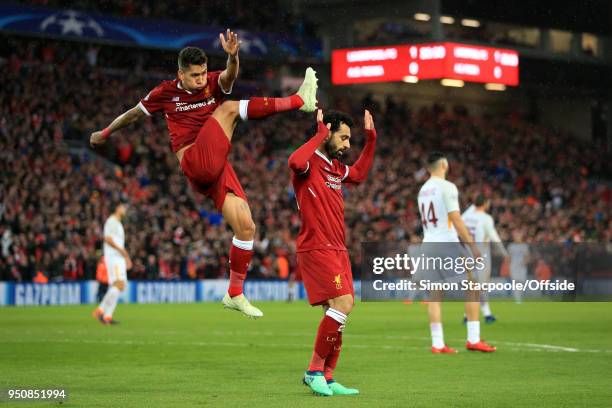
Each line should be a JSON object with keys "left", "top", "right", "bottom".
{"left": 461, "top": 194, "right": 509, "bottom": 323}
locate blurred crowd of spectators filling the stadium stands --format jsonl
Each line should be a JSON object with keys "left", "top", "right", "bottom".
{"left": 0, "top": 38, "right": 612, "bottom": 281}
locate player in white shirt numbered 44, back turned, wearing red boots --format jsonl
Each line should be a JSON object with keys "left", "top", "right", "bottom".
{"left": 415, "top": 152, "right": 496, "bottom": 353}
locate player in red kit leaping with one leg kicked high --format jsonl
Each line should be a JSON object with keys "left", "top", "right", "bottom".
{"left": 90, "top": 30, "right": 317, "bottom": 318}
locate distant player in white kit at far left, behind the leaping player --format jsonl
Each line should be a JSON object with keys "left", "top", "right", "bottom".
{"left": 93, "top": 203, "right": 132, "bottom": 324}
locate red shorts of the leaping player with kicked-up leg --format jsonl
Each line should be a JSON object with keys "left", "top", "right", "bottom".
{"left": 181, "top": 117, "right": 247, "bottom": 212}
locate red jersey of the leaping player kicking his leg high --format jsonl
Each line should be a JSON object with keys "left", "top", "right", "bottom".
{"left": 138, "top": 71, "right": 232, "bottom": 152}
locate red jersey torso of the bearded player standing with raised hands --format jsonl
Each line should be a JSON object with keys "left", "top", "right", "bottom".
{"left": 291, "top": 150, "right": 350, "bottom": 252}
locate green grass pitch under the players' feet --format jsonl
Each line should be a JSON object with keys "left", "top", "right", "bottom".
{"left": 0, "top": 302, "right": 612, "bottom": 408}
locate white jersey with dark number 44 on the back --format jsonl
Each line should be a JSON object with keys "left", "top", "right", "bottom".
{"left": 418, "top": 177, "right": 459, "bottom": 242}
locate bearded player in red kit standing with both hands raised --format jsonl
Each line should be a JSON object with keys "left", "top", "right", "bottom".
{"left": 289, "top": 110, "right": 376, "bottom": 396}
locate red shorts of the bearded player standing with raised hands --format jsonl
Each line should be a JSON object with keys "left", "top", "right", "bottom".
{"left": 297, "top": 249, "right": 355, "bottom": 306}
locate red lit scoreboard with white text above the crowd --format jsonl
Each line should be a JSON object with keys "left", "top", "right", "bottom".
{"left": 332, "top": 42, "right": 519, "bottom": 86}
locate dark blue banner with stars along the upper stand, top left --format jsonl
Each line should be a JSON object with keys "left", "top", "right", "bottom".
{"left": 0, "top": 4, "right": 323, "bottom": 60}
